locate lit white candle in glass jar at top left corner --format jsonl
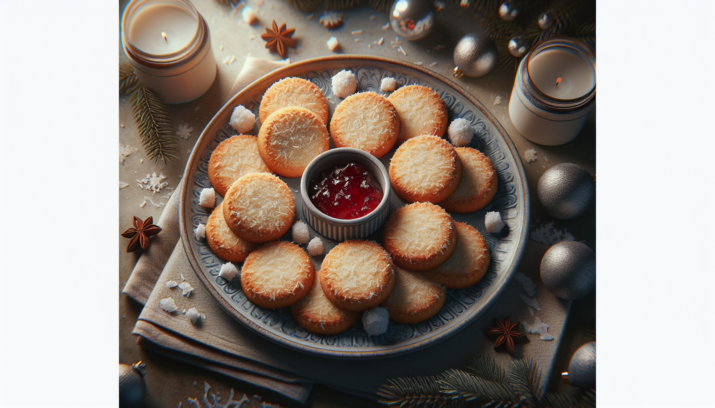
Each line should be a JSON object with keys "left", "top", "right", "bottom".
{"left": 122, "top": 0, "right": 216, "bottom": 103}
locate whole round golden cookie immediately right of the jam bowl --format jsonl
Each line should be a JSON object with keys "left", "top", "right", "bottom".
{"left": 389, "top": 136, "right": 462, "bottom": 204}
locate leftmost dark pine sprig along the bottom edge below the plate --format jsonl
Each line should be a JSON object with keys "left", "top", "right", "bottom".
{"left": 377, "top": 376, "right": 450, "bottom": 408}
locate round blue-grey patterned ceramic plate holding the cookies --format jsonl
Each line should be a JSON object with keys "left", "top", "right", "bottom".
{"left": 179, "top": 55, "right": 530, "bottom": 358}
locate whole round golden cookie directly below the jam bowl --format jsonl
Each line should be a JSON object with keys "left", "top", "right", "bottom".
{"left": 320, "top": 240, "right": 395, "bottom": 312}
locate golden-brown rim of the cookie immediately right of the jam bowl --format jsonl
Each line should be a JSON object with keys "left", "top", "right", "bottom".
{"left": 388, "top": 135, "right": 463, "bottom": 204}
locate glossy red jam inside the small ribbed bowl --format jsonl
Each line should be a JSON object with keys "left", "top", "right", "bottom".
{"left": 308, "top": 163, "right": 383, "bottom": 220}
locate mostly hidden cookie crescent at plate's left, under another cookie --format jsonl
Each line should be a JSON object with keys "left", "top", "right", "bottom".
{"left": 206, "top": 203, "right": 256, "bottom": 262}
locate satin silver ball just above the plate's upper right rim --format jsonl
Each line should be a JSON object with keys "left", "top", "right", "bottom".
{"left": 454, "top": 32, "right": 497, "bottom": 78}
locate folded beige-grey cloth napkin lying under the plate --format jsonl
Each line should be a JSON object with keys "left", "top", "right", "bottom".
{"left": 124, "top": 59, "right": 571, "bottom": 403}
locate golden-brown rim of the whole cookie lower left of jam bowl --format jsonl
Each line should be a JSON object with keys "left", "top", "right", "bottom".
{"left": 241, "top": 241, "right": 315, "bottom": 309}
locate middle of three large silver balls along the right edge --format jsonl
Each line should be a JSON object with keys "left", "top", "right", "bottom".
{"left": 539, "top": 241, "right": 596, "bottom": 300}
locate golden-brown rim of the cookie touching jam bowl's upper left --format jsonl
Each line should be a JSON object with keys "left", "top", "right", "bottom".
{"left": 258, "top": 106, "right": 330, "bottom": 178}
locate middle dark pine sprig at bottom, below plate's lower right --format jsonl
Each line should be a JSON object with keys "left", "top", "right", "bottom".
{"left": 439, "top": 369, "right": 519, "bottom": 407}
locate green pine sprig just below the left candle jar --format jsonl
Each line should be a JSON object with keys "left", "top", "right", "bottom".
{"left": 129, "top": 84, "right": 178, "bottom": 163}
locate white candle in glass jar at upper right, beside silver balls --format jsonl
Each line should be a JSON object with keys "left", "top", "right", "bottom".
{"left": 509, "top": 38, "right": 596, "bottom": 146}
